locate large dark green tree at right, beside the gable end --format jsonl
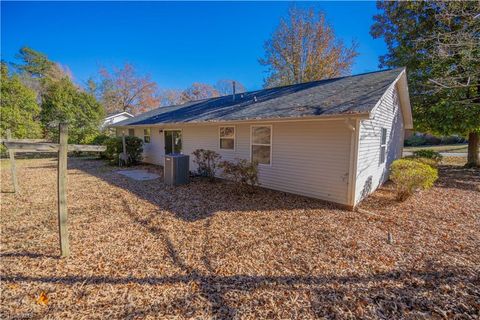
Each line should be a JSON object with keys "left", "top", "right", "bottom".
{"left": 371, "top": 1, "right": 480, "bottom": 166}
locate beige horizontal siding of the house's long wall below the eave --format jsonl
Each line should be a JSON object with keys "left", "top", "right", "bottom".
{"left": 120, "top": 120, "right": 351, "bottom": 204}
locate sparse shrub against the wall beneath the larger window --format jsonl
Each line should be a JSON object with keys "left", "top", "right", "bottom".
{"left": 220, "top": 159, "right": 258, "bottom": 191}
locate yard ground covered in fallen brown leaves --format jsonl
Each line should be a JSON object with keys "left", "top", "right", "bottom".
{"left": 0, "top": 159, "right": 480, "bottom": 319}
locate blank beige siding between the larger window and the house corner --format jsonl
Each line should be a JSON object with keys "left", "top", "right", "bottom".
{"left": 253, "top": 121, "right": 350, "bottom": 204}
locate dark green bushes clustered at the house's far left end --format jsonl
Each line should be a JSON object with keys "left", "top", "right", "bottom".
{"left": 103, "top": 136, "right": 143, "bottom": 165}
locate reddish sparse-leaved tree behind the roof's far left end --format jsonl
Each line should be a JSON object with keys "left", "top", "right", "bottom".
{"left": 98, "top": 63, "right": 160, "bottom": 114}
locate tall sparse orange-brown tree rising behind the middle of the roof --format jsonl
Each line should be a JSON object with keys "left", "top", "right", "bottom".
{"left": 259, "top": 7, "right": 358, "bottom": 87}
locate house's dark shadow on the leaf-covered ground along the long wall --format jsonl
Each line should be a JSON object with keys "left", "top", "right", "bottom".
{"left": 68, "top": 159, "right": 339, "bottom": 221}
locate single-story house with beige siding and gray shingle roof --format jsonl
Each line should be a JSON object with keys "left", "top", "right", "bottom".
{"left": 114, "top": 68, "right": 412, "bottom": 208}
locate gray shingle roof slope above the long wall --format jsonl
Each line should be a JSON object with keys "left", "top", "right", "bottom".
{"left": 115, "top": 68, "right": 404, "bottom": 126}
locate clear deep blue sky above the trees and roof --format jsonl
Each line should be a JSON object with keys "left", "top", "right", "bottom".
{"left": 1, "top": 1, "right": 386, "bottom": 90}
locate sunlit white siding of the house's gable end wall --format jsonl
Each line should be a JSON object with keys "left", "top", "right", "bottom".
{"left": 355, "top": 84, "right": 404, "bottom": 204}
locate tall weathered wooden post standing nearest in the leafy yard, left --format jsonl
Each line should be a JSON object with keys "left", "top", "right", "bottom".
{"left": 57, "top": 123, "right": 70, "bottom": 257}
